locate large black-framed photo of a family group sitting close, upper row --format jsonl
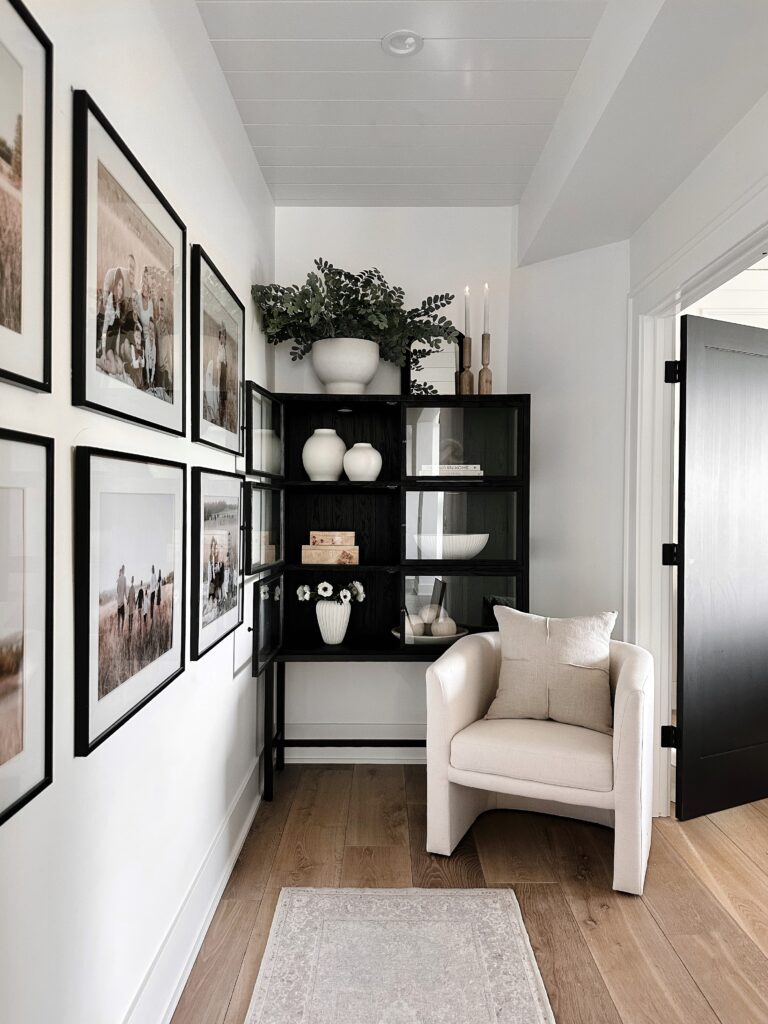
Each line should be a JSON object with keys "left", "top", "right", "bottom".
{"left": 72, "top": 90, "right": 186, "bottom": 434}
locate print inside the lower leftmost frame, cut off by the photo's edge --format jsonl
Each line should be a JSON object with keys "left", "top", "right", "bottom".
{"left": 0, "top": 487, "right": 25, "bottom": 765}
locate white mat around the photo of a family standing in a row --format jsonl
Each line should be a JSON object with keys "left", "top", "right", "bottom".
{"left": 88, "top": 456, "right": 184, "bottom": 741}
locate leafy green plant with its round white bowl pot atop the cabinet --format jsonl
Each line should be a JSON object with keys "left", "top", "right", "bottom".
{"left": 252, "top": 259, "right": 458, "bottom": 394}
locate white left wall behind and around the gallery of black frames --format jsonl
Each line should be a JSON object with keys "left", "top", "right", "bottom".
{"left": 0, "top": 0, "right": 273, "bottom": 1024}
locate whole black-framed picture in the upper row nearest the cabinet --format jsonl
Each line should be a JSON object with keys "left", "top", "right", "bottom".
{"left": 190, "top": 246, "right": 246, "bottom": 455}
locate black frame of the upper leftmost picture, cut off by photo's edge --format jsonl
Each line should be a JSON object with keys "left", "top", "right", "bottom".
{"left": 0, "top": 0, "right": 53, "bottom": 393}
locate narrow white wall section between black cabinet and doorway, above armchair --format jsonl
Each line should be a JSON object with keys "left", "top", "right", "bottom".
{"left": 509, "top": 242, "right": 629, "bottom": 626}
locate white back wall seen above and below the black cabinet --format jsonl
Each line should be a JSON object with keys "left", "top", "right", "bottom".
{"left": 274, "top": 207, "right": 515, "bottom": 761}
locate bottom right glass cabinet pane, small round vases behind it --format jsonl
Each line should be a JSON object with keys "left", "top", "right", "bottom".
{"left": 400, "top": 573, "right": 519, "bottom": 646}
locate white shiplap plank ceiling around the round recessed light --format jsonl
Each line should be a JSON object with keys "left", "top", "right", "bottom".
{"left": 198, "top": 0, "right": 606, "bottom": 206}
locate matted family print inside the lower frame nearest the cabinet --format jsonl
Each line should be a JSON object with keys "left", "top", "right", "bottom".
{"left": 200, "top": 496, "right": 240, "bottom": 628}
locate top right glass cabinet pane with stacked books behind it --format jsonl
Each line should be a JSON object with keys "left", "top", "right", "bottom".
{"left": 406, "top": 404, "right": 520, "bottom": 479}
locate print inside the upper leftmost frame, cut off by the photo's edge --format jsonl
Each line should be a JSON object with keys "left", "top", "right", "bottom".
{"left": 0, "top": 43, "right": 24, "bottom": 334}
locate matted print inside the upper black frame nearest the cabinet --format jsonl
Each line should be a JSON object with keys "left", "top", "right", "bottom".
{"left": 201, "top": 270, "right": 242, "bottom": 435}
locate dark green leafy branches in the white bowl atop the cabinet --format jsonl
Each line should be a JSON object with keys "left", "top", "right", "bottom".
{"left": 251, "top": 259, "right": 458, "bottom": 367}
